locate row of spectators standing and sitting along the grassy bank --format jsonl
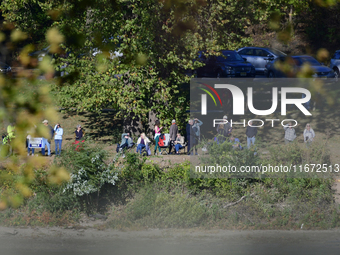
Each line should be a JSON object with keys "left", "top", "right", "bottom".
{"left": 21, "top": 115, "right": 315, "bottom": 159}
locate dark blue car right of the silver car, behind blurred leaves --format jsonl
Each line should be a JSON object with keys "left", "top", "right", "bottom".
{"left": 265, "top": 55, "right": 335, "bottom": 78}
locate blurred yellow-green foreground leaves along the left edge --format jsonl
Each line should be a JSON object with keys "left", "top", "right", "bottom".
{"left": 0, "top": 24, "right": 69, "bottom": 210}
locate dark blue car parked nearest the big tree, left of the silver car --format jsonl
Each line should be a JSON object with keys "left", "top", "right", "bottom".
{"left": 197, "top": 50, "right": 255, "bottom": 78}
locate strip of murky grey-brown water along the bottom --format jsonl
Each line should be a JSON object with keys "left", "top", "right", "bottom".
{"left": 0, "top": 227, "right": 340, "bottom": 255}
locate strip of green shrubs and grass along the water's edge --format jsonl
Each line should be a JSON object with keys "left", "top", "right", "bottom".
{"left": 0, "top": 138, "right": 340, "bottom": 229}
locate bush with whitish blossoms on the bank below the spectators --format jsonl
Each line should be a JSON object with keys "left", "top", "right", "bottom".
{"left": 50, "top": 141, "right": 118, "bottom": 213}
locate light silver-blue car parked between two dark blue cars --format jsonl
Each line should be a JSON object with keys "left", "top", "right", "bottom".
{"left": 237, "top": 47, "right": 286, "bottom": 74}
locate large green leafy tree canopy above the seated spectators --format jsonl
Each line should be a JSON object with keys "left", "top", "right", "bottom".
{"left": 3, "top": 0, "right": 322, "bottom": 129}
